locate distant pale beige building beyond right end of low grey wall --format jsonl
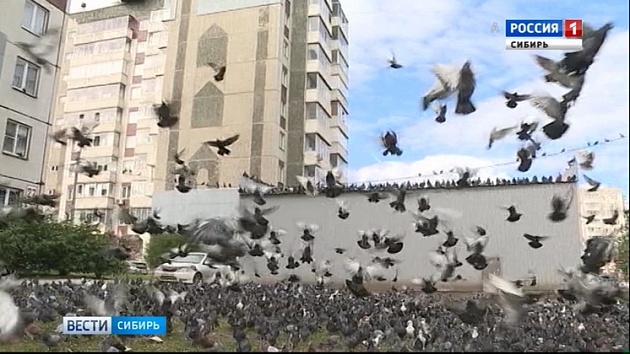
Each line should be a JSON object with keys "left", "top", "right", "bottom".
{"left": 579, "top": 187, "right": 626, "bottom": 240}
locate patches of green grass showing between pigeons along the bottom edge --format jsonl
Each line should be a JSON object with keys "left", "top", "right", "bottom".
{"left": 0, "top": 322, "right": 336, "bottom": 352}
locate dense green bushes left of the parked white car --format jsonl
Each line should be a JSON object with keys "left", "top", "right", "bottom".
{"left": 0, "top": 220, "right": 123, "bottom": 277}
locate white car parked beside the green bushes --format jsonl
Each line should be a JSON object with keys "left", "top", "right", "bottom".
{"left": 153, "top": 252, "right": 217, "bottom": 284}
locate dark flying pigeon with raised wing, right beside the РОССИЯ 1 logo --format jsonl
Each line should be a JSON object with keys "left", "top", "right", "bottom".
{"left": 560, "top": 22, "right": 614, "bottom": 75}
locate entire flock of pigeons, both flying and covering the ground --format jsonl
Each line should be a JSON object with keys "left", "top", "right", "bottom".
{"left": 0, "top": 2, "right": 628, "bottom": 352}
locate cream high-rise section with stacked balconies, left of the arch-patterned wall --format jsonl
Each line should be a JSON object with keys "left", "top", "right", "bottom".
{"left": 42, "top": 1, "right": 175, "bottom": 235}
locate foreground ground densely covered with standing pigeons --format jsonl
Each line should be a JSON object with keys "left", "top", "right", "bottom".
{"left": 0, "top": 280, "right": 630, "bottom": 352}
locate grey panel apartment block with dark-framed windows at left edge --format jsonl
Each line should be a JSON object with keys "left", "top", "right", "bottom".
{"left": 0, "top": 0, "right": 66, "bottom": 207}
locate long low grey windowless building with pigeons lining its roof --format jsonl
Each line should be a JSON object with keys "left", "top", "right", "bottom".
{"left": 153, "top": 183, "right": 583, "bottom": 290}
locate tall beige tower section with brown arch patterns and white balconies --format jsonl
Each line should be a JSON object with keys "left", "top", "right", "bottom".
{"left": 156, "top": 0, "right": 348, "bottom": 191}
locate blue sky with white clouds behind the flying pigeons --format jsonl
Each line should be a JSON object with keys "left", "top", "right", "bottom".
{"left": 342, "top": 0, "right": 630, "bottom": 201}
